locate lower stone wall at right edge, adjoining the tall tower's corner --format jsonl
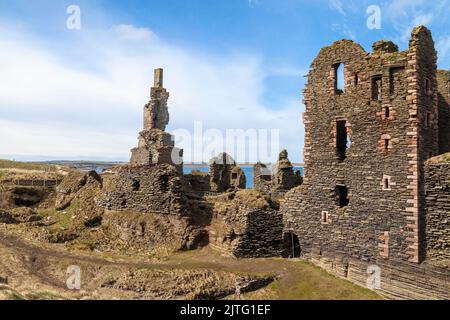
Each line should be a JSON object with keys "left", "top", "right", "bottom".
{"left": 425, "top": 154, "right": 450, "bottom": 266}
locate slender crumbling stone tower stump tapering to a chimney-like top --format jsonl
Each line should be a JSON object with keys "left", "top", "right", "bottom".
{"left": 130, "top": 69, "right": 183, "bottom": 173}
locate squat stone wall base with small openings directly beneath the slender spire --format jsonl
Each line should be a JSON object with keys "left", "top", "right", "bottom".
{"left": 97, "top": 164, "right": 187, "bottom": 215}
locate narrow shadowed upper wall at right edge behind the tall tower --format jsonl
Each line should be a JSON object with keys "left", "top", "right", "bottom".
{"left": 437, "top": 70, "right": 450, "bottom": 154}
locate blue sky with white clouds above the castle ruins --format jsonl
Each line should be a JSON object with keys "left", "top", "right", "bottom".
{"left": 0, "top": 0, "right": 450, "bottom": 162}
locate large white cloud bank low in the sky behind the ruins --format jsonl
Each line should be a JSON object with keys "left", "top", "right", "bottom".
{"left": 0, "top": 25, "right": 303, "bottom": 162}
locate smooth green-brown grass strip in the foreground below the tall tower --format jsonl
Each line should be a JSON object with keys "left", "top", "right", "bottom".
{"left": 161, "top": 249, "right": 383, "bottom": 300}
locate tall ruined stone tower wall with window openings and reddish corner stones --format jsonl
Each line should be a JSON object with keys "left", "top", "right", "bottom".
{"left": 281, "top": 27, "right": 438, "bottom": 262}
